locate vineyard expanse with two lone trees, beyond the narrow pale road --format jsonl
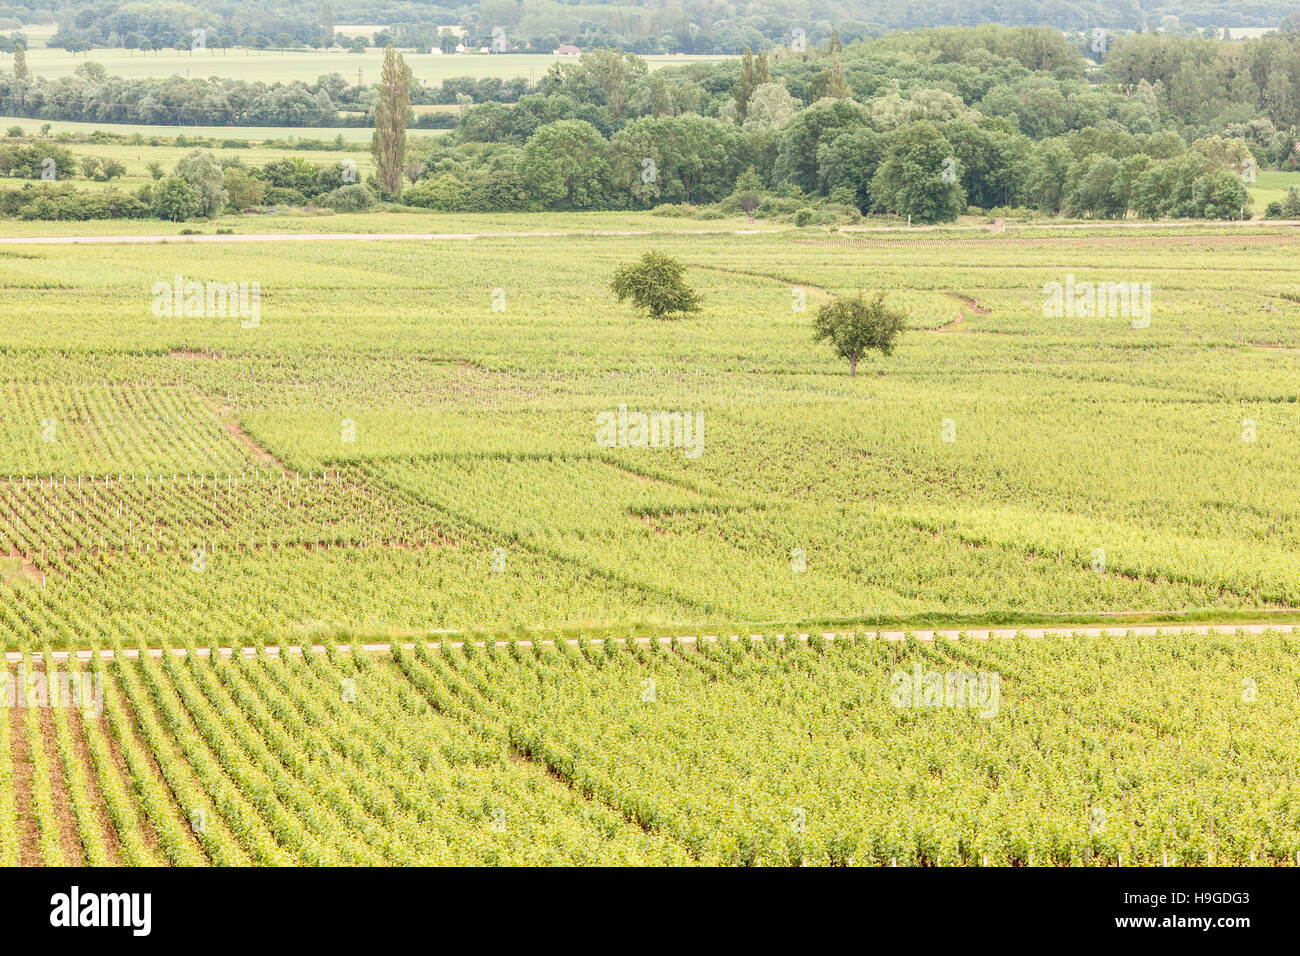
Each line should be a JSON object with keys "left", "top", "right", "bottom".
{"left": 0, "top": 217, "right": 1300, "bottom": 645}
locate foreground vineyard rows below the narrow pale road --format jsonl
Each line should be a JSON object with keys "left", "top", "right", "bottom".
{"left": 0, "top": 632, "right": 1300, "bottom": 866}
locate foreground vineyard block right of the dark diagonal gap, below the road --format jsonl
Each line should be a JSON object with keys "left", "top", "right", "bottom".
{"left": 384, "top": 635, "right": 1300, "bottom": 865}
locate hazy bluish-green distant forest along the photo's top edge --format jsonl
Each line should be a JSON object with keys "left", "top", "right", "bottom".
{"left": 0, "top": 0, "right": 1295, "bottom": 53}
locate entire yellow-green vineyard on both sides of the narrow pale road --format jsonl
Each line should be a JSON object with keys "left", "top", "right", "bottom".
{"left": 0, "top": 216, "right": 1300, "bottom": 866}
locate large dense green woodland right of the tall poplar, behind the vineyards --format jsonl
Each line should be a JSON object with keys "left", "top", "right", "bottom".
{"left": 403, "top": 27, "right": 1300, "bottom": 222}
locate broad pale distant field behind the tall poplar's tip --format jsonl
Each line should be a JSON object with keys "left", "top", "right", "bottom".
{"left": 0, "top": 48, "right": 735, "bottom": 85}
